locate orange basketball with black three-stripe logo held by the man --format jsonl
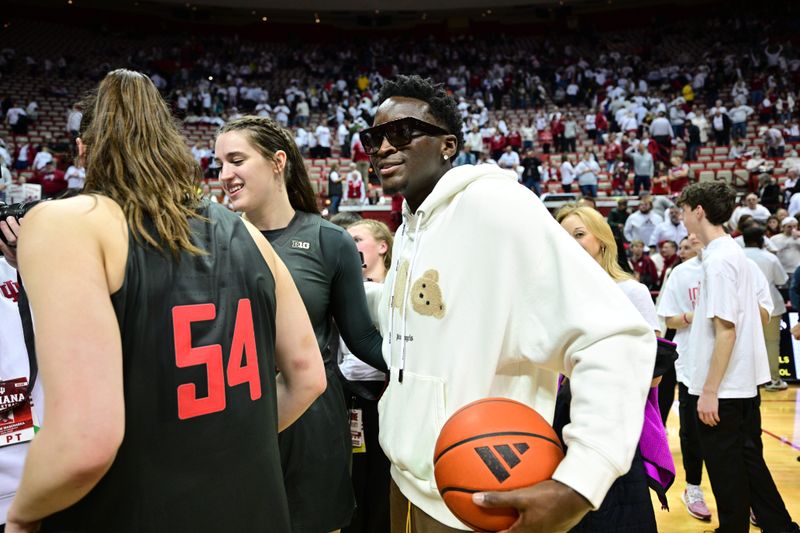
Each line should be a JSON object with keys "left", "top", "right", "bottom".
{"left": 433, "top": 398, "right": 564, "bottom": 531}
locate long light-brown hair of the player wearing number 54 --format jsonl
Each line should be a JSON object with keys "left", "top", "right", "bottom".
{"left": 80, "top": 69, "right": 205, "bottom": 257}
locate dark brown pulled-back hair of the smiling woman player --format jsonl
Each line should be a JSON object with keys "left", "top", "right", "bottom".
{"left": 217, "top": 116, "right": 319, "bottom": 214}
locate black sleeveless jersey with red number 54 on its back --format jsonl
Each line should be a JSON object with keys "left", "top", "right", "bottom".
{"left": 43, "top": 203, "right": 290, "bottom": 533}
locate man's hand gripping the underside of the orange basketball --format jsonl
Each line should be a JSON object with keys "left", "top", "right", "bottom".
{"left": 472, "top": 479, "right": 592, "bottom": 533}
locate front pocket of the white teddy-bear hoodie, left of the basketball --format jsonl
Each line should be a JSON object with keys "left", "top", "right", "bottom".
{"left": 378, "top": 371, "right": 445, "bottom": 483}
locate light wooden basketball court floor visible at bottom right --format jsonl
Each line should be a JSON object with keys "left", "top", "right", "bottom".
{"left": 651, "top": 384, "right": 800, "bottom": 533}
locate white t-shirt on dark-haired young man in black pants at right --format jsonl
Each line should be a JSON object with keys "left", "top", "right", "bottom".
{"left": 685, "top": 235, "right": 772, "bottom": 398}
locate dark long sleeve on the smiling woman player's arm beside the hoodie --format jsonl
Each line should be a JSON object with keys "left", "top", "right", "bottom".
{"left": 320, "top": 226, "right": 388, "bottom": 373}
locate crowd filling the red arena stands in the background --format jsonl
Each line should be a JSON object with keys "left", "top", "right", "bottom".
{"left": 0, "top": 11, "right": 800, "bottom": 208}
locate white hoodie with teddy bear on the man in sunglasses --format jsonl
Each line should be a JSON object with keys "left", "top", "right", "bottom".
{"left": 378, "top": 165, "right": 656, "bottom": 529}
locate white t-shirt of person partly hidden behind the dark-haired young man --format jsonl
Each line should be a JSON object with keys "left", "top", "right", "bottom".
{"left": 657, "top": 257, "right": 703, "bottom": 386}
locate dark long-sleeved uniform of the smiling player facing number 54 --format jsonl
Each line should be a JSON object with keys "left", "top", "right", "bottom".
{"left": 262, "top": 211, "right": 386, "bottom": 533}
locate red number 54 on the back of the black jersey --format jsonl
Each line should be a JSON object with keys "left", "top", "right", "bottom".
{"left": 172, "top": 298, "right": 261, "bottom": 420}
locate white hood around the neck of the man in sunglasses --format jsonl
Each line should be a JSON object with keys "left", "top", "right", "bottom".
{"left": 403, "top": 165, "right": 517, "bottom": 228}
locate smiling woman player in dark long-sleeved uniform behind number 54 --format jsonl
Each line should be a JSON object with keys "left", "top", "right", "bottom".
{"left": 216, "top": 117, "right": 386, "bottom": 533}
